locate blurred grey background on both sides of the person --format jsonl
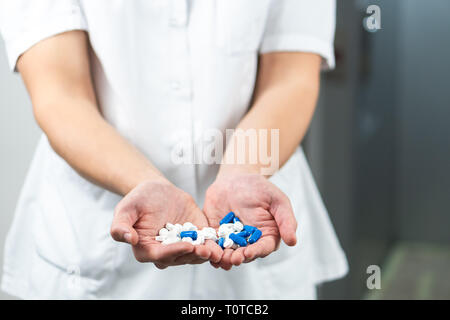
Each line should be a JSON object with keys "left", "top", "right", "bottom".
{"left": 0, "top": 0, "right": 450, "bottom": 299}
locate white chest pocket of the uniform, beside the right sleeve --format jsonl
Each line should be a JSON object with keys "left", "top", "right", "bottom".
{"left": 216, "top": 0, "right": 269, "bottom": 55}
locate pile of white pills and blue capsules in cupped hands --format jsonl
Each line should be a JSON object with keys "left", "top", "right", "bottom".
{"left": 156, "top": 211, "right": 262, "bottom": 249}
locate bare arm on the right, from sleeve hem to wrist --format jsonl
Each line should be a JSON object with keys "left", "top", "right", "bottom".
{"left": 219, "top": 52, "right": 320, "bottom": 176}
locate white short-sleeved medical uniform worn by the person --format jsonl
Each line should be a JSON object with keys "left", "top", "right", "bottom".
{"left": 0, "top": 0, "right": 347, "bottom": 299}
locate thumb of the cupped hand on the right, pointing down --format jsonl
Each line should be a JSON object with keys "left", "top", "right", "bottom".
{"left": 270, "top": 190, "right": 297, "bottom": 246}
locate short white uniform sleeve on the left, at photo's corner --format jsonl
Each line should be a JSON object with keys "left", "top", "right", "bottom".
{"left": 0, "top": 0, "right": 87, "bottom": 71}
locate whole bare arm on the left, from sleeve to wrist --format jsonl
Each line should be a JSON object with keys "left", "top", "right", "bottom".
{"left": 17, "top": 31, "right": 167, "bottom": 194}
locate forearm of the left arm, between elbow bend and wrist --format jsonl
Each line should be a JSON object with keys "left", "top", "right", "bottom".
{"left": 35, "top": 97, "right": 163, "bottom": 195}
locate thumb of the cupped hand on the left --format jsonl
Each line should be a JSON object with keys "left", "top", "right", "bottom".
{"left": 110, "top": 204, "right": 139, "bottom": 245}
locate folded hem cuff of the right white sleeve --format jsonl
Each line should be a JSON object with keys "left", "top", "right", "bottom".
{"left": 259, "top": 35, "right": 335, "bottom": 70}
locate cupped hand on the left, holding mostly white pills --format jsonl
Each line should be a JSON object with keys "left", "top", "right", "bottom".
{"left": 111, "top": 179, "right": 223, "bottom": 269}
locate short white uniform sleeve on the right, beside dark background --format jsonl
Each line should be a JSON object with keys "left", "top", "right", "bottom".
{"left": 260, "top": 0, "right": 336, "bottom": 69}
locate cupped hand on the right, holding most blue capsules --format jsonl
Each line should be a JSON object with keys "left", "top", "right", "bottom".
{"left": 203, "top": 174, "right": 297, "bottom": 270}
